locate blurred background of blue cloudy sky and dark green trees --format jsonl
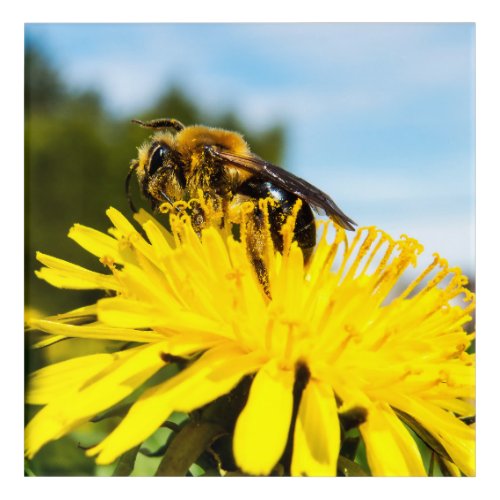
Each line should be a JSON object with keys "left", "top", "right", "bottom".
{"left": 25, "top": 23, "right": 475, "bottom": 475}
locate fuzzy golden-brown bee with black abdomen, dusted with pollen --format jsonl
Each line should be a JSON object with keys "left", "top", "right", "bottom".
{"left": 126, "top": 118, "right": 355, "bottom": 281}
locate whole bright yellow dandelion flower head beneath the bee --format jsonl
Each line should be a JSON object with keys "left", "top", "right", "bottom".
{"left": 26, "top": 200, "right": 475, "bottom": 476}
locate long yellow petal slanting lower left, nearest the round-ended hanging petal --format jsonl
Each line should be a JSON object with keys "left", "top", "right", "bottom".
{"left": 87, "top": 345, "right": 259, "bottom": 464}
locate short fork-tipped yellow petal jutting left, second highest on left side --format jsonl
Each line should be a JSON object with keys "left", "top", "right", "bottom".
{"left": 35, "top": 252, "right": 120, "bottom": 290}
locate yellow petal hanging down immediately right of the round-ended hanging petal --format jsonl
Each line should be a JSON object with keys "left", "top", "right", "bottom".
{"left": 291, "top": 381, "right": 340, "bottom": 476}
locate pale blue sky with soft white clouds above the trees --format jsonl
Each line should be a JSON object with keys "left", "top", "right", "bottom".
{"left": 26, "top": 23, "right": 475, "bottom": 273}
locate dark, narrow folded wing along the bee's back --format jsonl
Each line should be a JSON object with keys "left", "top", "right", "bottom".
{"left": 210, "top": 148, "right": 356, "bottom": 231}
